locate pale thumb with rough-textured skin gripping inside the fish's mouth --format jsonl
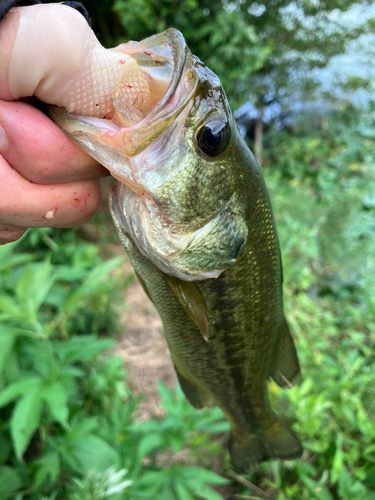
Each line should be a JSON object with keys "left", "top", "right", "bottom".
{"left": 0, "top": 4, "right": 147, "bottom": 117}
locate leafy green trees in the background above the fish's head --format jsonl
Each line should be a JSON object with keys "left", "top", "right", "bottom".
{"left": 86, "top": 0, "right": 374, "bottom": 161}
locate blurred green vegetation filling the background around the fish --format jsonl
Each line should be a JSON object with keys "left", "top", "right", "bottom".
{"left": 0, "top": 0, "right": 375, "bottom": 500}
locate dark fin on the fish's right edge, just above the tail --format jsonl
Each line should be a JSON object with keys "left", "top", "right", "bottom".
{"left": 270, "top": 319, "right": 301, "bottom": 387}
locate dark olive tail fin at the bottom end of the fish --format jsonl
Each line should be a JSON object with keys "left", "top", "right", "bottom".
{"left": 229, "top": 417, "right": 303, "bottom": 474}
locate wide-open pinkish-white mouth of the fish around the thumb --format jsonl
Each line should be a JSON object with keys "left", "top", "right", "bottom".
{"left": 47, "top": 29, "right": 198, "bottom": 178}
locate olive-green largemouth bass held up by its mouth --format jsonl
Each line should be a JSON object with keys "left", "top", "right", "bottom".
{"left": 50, "top": 29, "right": 302, "bottom": 474}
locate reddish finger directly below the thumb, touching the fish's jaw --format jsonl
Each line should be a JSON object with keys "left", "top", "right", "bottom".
{"left": 0, "top": 101, "right": 108, "bottom": 184}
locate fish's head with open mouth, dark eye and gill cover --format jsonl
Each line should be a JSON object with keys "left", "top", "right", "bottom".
{"left": 50, "top": 30, "right": 248, "bottom": 281}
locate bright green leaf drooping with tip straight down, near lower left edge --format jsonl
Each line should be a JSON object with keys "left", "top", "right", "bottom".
{"left": 10, "top": 388, "right": 42, "bottom": 460}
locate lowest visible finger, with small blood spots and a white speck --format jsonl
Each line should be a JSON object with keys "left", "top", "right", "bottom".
{"left": 0, "top": 157, "right": 101, "bottom": 228}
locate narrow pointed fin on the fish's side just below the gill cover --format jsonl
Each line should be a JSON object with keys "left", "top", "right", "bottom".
{"left": 165, "top": 275, "right": 208, "bottom": 342}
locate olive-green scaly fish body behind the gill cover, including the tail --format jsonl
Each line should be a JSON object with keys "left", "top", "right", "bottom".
{"left": 112, "top": 139, "right": 301, "bottom": 472}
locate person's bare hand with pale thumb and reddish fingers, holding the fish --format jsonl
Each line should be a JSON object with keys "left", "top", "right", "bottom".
{"left": 0, "top": 4, "right": 131, "bottom": 244}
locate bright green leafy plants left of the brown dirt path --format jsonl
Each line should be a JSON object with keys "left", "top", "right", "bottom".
{"left": 0, "top": 232, "right": 226, "bottom": 500}
